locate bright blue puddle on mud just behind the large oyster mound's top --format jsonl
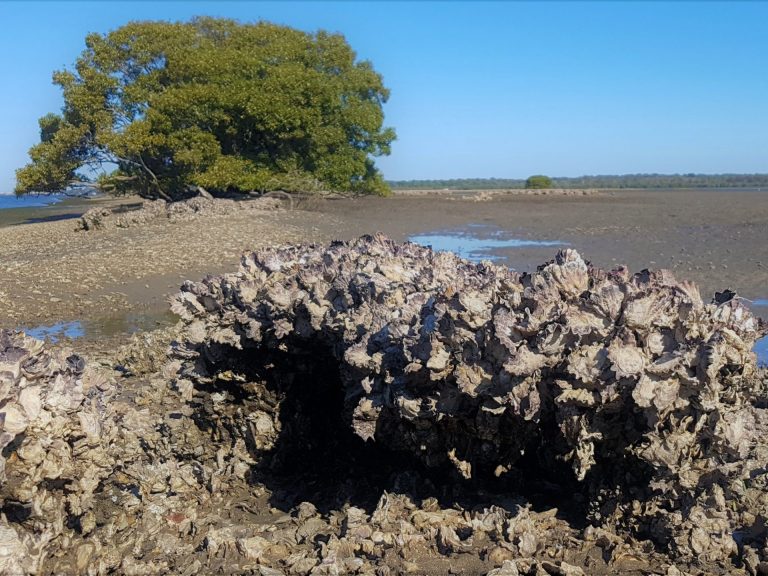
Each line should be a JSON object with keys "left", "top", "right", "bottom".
{"left": 408, "top": 224, "right": 565, "bottom": 262}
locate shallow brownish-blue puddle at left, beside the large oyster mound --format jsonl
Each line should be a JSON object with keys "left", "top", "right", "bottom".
{"left": 18, "top": 311, "right": 178, "bottom": 342}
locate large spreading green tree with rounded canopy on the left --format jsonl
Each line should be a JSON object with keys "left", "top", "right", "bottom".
{"left": 16, "top": 18, "right": 395, "bottom": 199}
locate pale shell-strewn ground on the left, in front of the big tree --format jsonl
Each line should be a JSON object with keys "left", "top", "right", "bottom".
{"left": 0, "top": 202, "right": 340, "bottom": 335}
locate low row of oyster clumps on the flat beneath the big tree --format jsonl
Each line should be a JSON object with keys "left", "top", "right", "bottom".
{"left": 78, "top": 196, "right": 282, "bottom": 230}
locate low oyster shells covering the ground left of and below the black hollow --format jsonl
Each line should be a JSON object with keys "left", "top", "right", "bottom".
{"left": 0, "top": 331, "right": 619, "bottom": 576}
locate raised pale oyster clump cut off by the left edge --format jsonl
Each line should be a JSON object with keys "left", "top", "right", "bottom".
{"left": 0, "top": 330, "right": 114, "bottom": 575}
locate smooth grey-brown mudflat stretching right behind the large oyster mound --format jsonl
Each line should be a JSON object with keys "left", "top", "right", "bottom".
{"left": 322, "top": 190, "right": 768, "bottom": 306}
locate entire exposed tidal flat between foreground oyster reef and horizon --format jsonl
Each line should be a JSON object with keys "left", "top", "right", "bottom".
{"left": 0, "top": 190, "right": 768, "bottom": 346}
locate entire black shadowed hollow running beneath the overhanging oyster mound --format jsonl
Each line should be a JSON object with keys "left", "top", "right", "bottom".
{"left": 189, "top": 341, "right": 585, "bottom": 528}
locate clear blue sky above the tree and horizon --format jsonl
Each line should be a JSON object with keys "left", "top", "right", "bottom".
{"left": 0, "top": 1, "right": 768, "bottom": 192}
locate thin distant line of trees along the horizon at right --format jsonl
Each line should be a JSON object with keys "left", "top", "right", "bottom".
{"left": 389, "top": 174, "right": 768, "bottom": 190}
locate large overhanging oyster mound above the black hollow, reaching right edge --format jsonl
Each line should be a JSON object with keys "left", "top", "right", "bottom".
{"left": 172, "top": 236, "right": 768, "bottom": 561}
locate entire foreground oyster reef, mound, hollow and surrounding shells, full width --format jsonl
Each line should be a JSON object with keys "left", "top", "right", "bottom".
{"left": 0, "top": 236, "right": 768, "bottom": 576}
